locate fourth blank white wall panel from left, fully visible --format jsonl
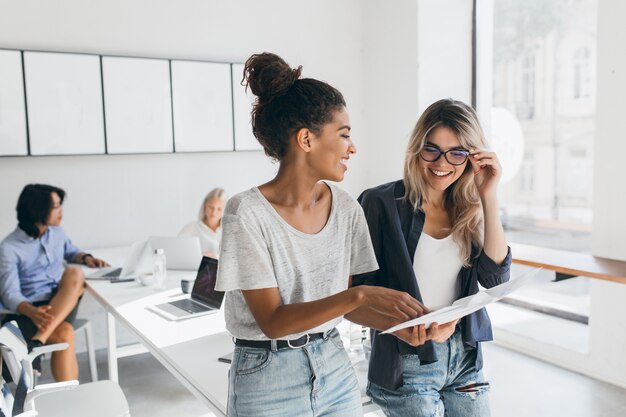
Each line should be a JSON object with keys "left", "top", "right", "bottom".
{"left": 171, "top": 60, "right": 234, "bottom": 152}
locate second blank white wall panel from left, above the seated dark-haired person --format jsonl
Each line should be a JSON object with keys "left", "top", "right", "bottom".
{"left": 24, "top": 51, "right": 104, "bottom": 155}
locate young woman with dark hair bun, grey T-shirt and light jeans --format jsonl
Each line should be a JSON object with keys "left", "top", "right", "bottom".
{"left": 217, "top": 53, "right": 422, "bottom": 417}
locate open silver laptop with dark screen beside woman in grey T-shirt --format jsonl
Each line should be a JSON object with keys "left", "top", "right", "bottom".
{"left": 146, "top": 256, "right": 224, "bottom": 320}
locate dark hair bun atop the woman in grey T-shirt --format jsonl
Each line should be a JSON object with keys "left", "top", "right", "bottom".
{"left": 243, "top": 52, "right": 302, "bottom": 102}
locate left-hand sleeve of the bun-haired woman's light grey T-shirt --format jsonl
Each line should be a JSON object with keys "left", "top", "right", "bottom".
{"left": 215, "top": 213, "right": 278, "bottom": 291}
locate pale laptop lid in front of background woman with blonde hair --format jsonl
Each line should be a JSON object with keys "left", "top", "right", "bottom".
{"left": 148, "top": 236, "right": 202, "bottom": 271}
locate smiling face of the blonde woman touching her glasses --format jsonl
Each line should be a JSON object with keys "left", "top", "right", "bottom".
{"left": 418, "top": 126, "right": 468, "bottom": 192}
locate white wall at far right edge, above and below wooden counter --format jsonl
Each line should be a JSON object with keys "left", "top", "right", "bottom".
{"left": 590, "top": 0, "right": 626, "bottom": 387}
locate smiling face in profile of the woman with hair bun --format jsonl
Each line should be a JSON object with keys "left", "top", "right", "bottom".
{"left": 308, "top": 108, "right": 356, "bottom": 181}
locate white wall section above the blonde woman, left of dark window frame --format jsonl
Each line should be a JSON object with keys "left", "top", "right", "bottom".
{"left": 363, "top": 0, "right": 472, "bottom": 187}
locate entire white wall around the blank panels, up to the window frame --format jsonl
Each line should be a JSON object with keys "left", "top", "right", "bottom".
{"left": 0, "top": 0, "right": 472, "bottom": 244}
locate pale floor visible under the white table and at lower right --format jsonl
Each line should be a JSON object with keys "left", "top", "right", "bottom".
{"left": 40, "top": 344, "right": 626, "bottom": 417}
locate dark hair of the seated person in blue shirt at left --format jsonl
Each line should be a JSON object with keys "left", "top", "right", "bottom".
{"left": 15, "top": 184, "right": 65, "bottom": 239}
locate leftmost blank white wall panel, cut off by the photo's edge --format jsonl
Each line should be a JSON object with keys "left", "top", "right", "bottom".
{"left": 0, "top": 50, "right": 27, "bottom": 156}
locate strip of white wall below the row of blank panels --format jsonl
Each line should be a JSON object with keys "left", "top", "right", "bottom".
{"left": 0, "top": 152, "right": 275, "bottom": 248}
